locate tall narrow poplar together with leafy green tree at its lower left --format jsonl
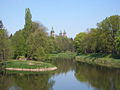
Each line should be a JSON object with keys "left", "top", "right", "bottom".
{"left": 12, "top": 8, "right": 32, "bottom": 58}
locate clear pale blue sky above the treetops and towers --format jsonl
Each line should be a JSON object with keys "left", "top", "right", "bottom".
{"left": 0, "top": 0, "right": 120, "bottom": 38}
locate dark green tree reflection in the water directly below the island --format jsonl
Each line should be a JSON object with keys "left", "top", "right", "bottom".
{"left": 0, "top": 74, "right": 55, "bottom": 90}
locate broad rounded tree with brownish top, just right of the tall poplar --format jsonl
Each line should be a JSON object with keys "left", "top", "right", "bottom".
{"left": 27, "top": 22, "right": 49, "bottom": 60}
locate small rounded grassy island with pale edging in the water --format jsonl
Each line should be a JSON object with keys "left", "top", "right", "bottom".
{"left": 5, "top": 60, "right": 57, "bottom": 72}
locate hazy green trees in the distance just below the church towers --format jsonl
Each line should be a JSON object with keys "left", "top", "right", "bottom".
{"left": 49, "top": 36, "right": 74, "bottom": 53}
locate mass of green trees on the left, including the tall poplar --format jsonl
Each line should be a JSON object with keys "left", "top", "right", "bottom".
{"left": 0, "top": 8, "right": 74, "bottom": 60}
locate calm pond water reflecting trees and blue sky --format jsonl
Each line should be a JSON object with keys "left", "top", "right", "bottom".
{"left": 0, "top": 60, "right": 120, "bottom": 90}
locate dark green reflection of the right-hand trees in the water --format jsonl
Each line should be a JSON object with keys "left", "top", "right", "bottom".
{"left": 75, "top": 63, "right": 120, "bottom": 90}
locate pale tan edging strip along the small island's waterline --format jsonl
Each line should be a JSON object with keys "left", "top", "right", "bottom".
{"left": 5, "top": 67, "right": 57, "bottom": 72}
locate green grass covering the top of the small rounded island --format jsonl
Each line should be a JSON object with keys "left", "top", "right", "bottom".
{"left": 6, "top": 60, "right": 55, "bottom": 69}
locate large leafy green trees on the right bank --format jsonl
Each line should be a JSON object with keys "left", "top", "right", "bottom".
{"left": 74, "top": 15, "right": 120, "bottom": 54}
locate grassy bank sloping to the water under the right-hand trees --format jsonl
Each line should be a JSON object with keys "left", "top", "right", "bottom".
{"left": 76, "top": 54, "right": 120, "bottom": 68}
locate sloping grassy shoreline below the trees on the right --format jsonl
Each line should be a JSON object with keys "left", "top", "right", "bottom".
{"left": 75, "top": 55, "right": 120, "bottom": 69}
